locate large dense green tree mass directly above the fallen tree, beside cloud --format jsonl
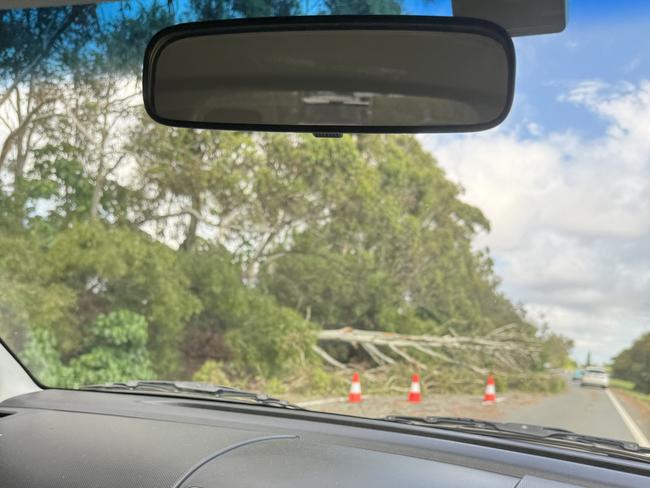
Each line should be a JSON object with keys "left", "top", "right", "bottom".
{"left": 262, "top": 136, "right": 535, "bottom": 344}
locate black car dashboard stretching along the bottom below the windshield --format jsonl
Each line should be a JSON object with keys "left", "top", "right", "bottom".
{"left": 0, "top": 390, "right": 650, "bottom": 488}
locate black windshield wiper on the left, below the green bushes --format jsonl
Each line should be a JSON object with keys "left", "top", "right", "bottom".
{"left": 79, "top": 380, "right": 305, "bottom": 410}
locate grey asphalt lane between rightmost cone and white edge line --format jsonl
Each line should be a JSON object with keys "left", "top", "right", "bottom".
{"left": 504, "top": 384, "right": 639, "bottom": 442}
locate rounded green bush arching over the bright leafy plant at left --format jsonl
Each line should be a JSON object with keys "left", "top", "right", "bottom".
{"left": 48, "top": 223, "right": 200, "bottom": 375}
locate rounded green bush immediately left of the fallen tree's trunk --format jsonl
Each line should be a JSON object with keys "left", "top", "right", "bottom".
{"left": 182, "top": 243, "right": 315, "bottom": 377}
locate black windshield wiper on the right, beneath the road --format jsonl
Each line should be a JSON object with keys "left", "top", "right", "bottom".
{"left": 383, "top": 415, "right": 650, "bottom": 462}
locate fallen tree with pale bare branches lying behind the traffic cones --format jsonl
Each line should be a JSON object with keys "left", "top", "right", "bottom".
{"left": 313, "top": 324, "right": 540, "bottom": 374}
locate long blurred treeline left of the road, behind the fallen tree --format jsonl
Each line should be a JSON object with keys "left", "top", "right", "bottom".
{"left": 0, "top": 0, "right": 571, "bottom": 385}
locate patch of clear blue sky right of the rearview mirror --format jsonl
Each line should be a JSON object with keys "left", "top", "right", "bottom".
{"left": 510, "top": 0, "right": 650, "bottom": 135}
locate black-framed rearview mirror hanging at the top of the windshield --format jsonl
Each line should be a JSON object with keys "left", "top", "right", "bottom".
{"left": 143, "top": 16, "right": 515, "bottom": 133}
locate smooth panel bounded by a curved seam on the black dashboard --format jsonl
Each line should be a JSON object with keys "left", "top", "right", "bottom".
{"left": 179, "top": 439, "right": 519, "bottom": 488}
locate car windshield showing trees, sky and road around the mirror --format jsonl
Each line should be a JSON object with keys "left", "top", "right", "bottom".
{"left": 0, "top": 0, "right": 650, "bottom": 450}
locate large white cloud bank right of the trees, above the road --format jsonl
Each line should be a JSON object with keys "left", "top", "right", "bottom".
{"left": 423, "top": 80, "right": 650, "bottom": 361}
